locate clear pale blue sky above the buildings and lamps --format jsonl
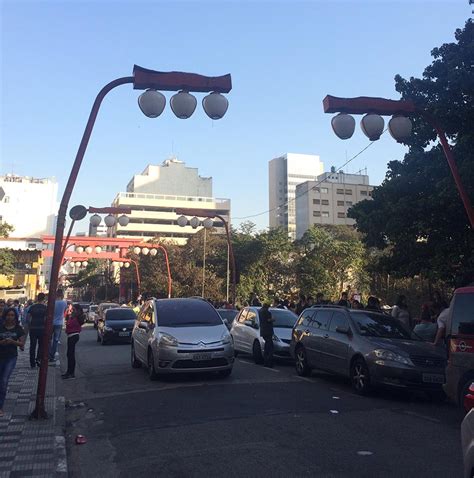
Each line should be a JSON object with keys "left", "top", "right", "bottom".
{"left": 1, "top": 0, "right": 471, "bottom": 230}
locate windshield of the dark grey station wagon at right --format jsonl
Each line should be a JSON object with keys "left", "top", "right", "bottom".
{"left": 351, "top": 312, "right": 421, "bottom": 340}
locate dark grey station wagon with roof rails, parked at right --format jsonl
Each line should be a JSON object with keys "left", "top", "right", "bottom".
{"left": 290, "top": 306, "right": 446, "bottom": 396}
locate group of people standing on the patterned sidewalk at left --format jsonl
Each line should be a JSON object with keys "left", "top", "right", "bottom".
{"left": 0, "top": 290, "right": 85, "bottom": 417}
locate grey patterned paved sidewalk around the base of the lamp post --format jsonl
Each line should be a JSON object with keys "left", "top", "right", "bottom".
{"left": 0, "top": 342, "right": 67, "bottom": 478}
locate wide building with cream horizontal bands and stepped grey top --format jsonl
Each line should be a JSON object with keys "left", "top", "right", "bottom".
{"left": 112, "top": 158, "right": 230, "bottom": 244}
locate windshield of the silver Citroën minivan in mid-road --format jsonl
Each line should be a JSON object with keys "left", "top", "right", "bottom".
{"left": 155, "top": 299, "right": 223, "bottom": 327}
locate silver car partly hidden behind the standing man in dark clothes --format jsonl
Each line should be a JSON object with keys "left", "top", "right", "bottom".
{"left": 230, "top": 307, "right": 298, "bottom": 363}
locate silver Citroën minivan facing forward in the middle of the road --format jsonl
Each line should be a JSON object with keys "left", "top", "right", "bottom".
{"left": 131, "top": 299, "right": 234, "bottom": 380}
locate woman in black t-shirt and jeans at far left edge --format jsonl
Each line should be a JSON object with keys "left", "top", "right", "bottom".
{"left": 0, "top": 308, "right": 25, "bottom": 417}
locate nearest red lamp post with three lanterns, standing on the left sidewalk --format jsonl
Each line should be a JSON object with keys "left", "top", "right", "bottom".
{"left": 31, "top": 65, "right": 232, "bottom": 419}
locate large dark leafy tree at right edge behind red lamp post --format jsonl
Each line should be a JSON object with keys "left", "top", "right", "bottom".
{"left": 349, "top": 20, "right": 474, "bottom": 285}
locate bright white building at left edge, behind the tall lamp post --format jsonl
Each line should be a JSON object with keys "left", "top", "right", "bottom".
{"left": 0, "top": 174, "right": 58, "bottom": 238}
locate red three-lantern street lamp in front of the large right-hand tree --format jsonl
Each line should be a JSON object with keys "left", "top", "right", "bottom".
{"left": 323, "top": 95, "right": 474, "bottom": 229}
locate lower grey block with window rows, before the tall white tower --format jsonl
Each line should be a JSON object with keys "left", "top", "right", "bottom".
{"left": 296, "top": 171, "right": 374, "bottom": 239}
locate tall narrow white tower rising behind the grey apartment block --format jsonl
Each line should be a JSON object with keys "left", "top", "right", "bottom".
{"left": 268, "top": 153, "right": 324, "bottom": 239}
